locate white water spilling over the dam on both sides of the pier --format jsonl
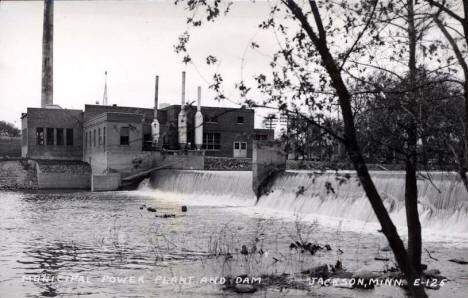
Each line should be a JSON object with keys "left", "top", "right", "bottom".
{"left": 140, "top": 171, "right": 468, "bottom": 244}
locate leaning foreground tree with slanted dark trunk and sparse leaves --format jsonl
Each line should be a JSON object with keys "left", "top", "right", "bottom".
{"left": 176, "top": 0, "right": 426, "bottom": 297}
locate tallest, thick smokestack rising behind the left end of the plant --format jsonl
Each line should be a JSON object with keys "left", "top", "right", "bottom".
{"left": 41, "top": 0, "right": 54, "bottom": 108}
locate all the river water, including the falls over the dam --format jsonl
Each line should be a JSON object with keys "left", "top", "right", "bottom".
{"left": 0, "top": 171, "right": 468, "bottom": 297}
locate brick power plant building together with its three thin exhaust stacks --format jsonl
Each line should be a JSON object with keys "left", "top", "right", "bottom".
{"left": 21, "top": 74, "right": 273, "bottom": 183}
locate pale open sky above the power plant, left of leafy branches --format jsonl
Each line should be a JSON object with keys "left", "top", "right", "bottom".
{"left": 0, "top": 0, "right": 276, "bottom": 127}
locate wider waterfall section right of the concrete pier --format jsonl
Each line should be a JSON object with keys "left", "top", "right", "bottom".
{"left": 257, "top": 171, "right": 468, "bottom": 233}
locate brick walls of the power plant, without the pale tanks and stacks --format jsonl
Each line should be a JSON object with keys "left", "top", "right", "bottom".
{"left": 22, "top": 105, "right": 273, "bottom": 164}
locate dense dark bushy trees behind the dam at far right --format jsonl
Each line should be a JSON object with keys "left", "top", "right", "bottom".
{"left": 355, "top": 68, "right": 464, "bottom": 170}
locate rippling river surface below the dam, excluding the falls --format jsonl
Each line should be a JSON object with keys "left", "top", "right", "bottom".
{"left": 0, "top": 192, "right": 467, "bottom": 297}
